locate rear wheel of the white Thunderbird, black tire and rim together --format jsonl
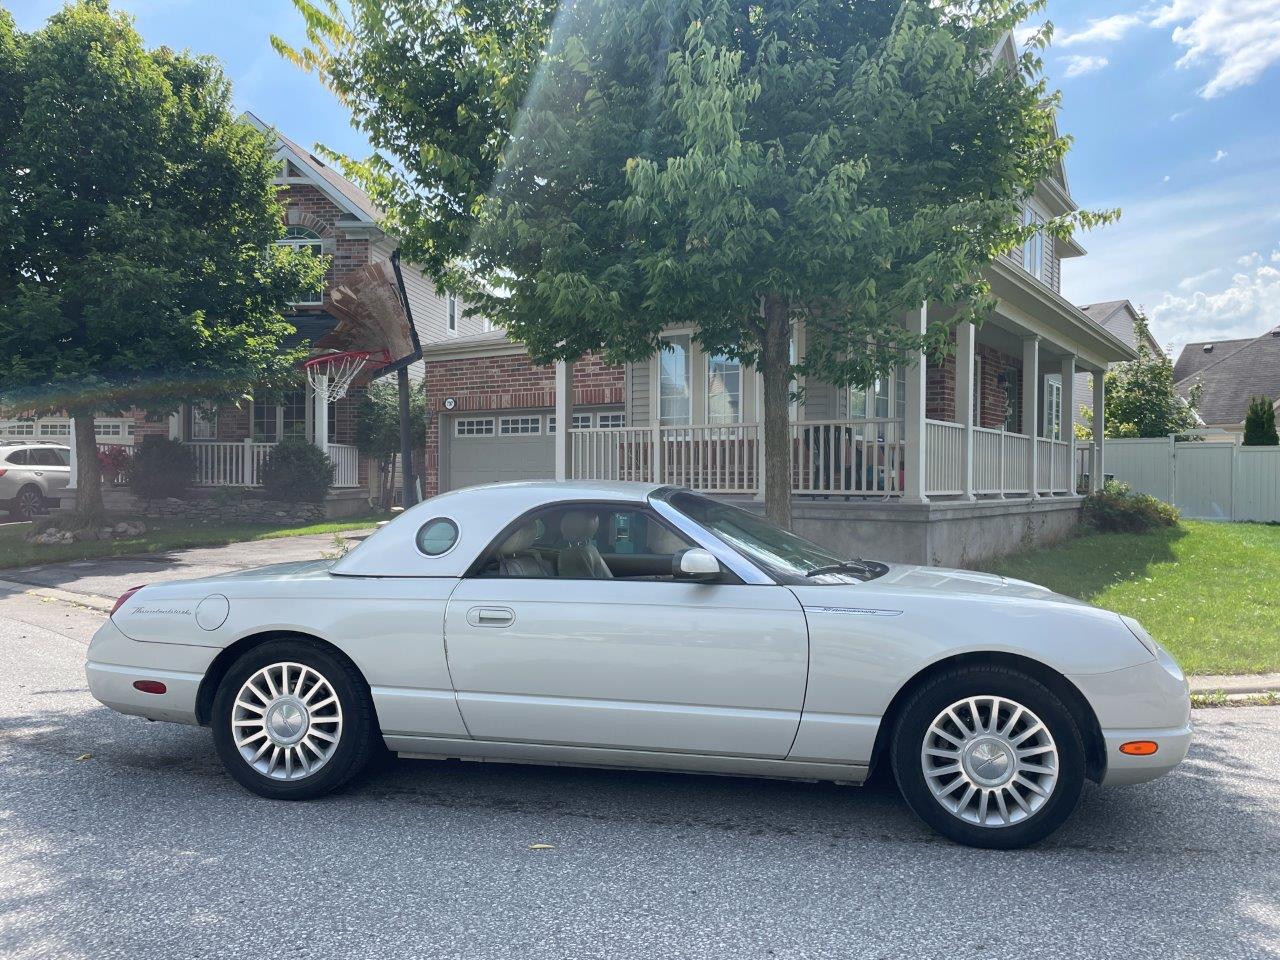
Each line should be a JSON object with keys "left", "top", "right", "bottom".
{"left": 211, "top": 639, "right": 381, "bottom": 800}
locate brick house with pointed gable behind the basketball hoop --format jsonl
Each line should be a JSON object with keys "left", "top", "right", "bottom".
{"left": 46, "top": 114, "right": 486, "bottom": 516}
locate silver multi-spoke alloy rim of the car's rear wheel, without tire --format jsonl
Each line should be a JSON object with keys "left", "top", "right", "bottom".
{"left": 230, "top": 663, "right": 342, "bottom": 781}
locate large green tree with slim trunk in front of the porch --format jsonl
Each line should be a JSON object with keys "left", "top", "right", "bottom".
{"left": 276, "top": 0, "right": 1111, "bottom": 524}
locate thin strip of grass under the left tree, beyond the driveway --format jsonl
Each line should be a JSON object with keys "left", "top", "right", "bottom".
{"left": 0, "top": 515, "right": 387, "bottom": 570}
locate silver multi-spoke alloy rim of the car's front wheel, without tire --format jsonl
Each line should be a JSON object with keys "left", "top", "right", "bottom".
{"left": 920, "top": 696, "right": 1060, "bottom": 828}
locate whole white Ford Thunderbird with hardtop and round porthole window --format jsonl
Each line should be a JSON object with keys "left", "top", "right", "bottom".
{"left": 87, "top": 483, "right": 1192, "bottom": 847}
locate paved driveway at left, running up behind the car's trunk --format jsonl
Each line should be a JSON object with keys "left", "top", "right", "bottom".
{"left": 0, "top": 530, "right": 371, "bottom": 600}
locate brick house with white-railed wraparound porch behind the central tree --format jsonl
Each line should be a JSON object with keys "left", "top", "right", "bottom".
{"left": 424, "top": 41, "right": 1137, "bottom": 564}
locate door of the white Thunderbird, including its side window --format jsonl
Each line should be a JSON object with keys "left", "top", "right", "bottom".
{"left": 445, "top": 504, "right": 809, "bottom": 758}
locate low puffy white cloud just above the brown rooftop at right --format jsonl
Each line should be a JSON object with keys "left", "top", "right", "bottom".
{"left": 1149, "top": 247, "right": 1280, "bottom": 349}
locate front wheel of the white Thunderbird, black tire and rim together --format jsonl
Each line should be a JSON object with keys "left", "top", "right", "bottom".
{"left": 890, "top": 667, "right": 1085, "bottom": 850}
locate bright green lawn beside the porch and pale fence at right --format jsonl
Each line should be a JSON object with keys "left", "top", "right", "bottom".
{"left": 989, "top": 521, "right": 1280, "bottom": 673}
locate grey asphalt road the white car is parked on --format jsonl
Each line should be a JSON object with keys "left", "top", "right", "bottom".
{"left": 0, "top": 583, "right": 1280, "bottom": 960}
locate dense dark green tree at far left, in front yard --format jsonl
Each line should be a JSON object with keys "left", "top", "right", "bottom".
{"left": 0, "top": 0, "right": 324, "bottom": 522}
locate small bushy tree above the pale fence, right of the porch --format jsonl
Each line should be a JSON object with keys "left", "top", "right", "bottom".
{"left": 1083, "top": 314, "right": 1203, "bottom": 438}
